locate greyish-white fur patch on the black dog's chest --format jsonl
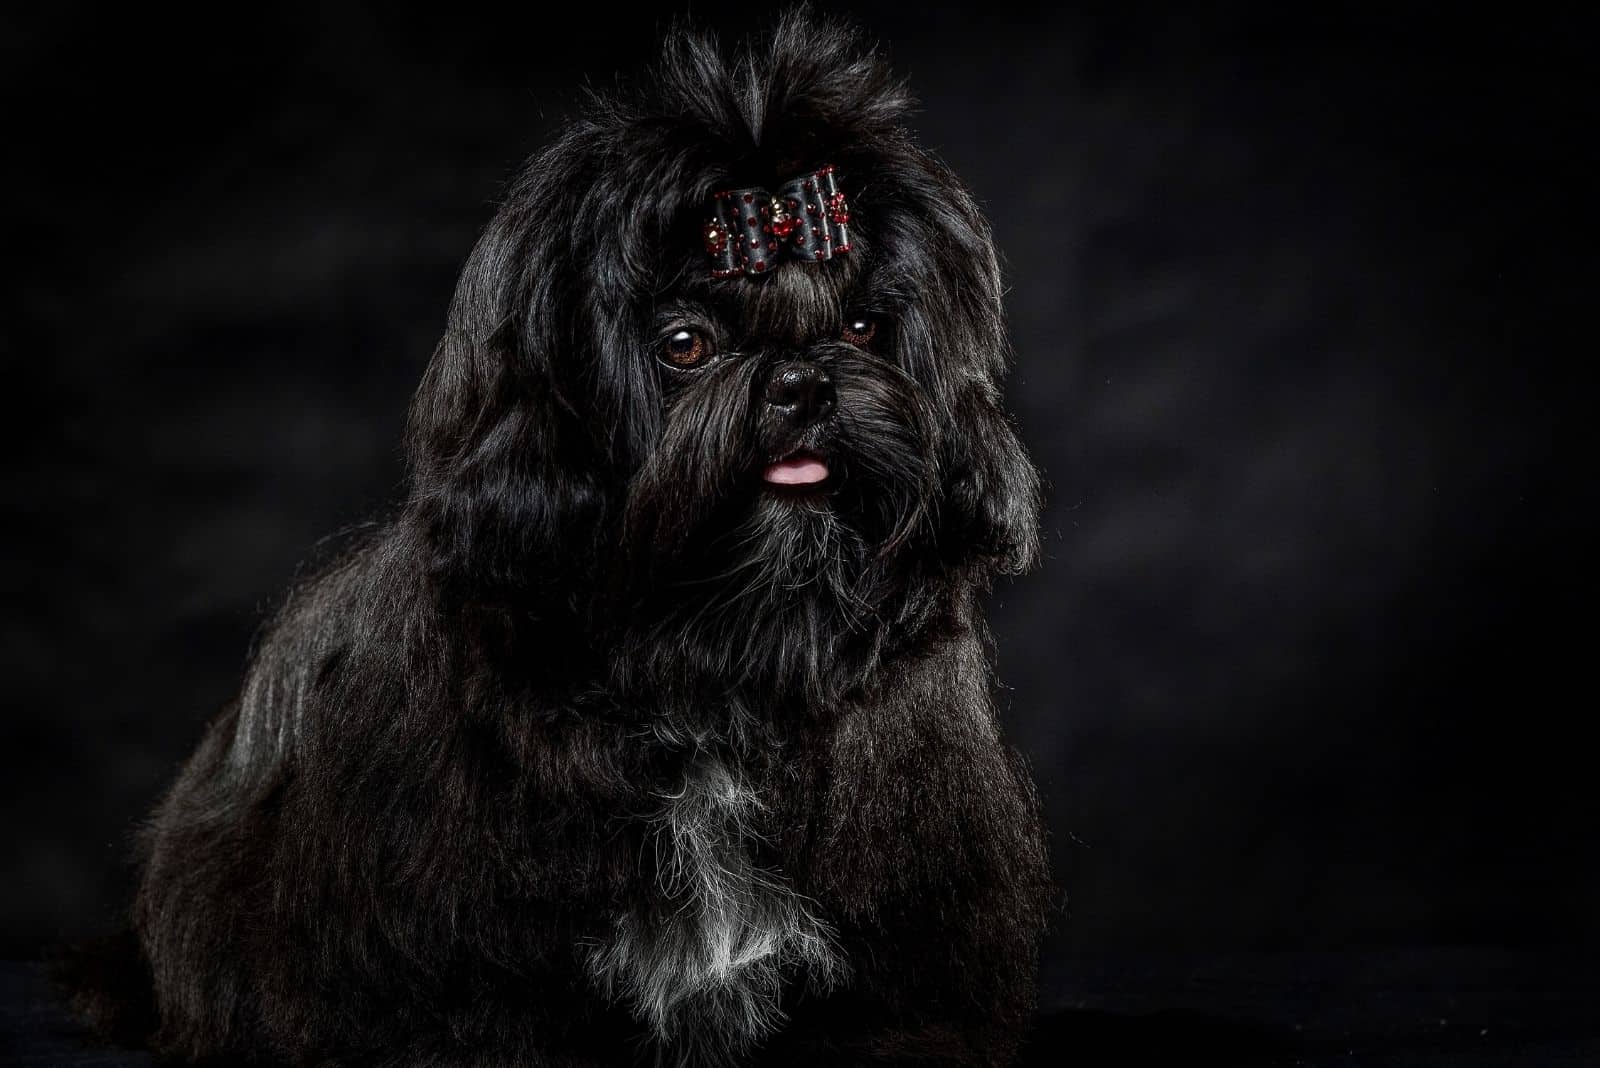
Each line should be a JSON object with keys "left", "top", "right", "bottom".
{"left": 587, "top": 758, "right": 843, "bottom": 1058}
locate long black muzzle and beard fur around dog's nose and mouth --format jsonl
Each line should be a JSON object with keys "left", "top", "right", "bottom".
{"left": 608, "top": 345, "right": 938, "bottom": 703}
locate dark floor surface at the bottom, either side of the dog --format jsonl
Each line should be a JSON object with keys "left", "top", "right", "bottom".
{"left": 0, "top": 950, "right": 1600, "bottom": 1068}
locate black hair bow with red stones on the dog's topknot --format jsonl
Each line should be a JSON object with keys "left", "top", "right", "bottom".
{"left": 704, "top": 165, "right": 850, "bottom": 278}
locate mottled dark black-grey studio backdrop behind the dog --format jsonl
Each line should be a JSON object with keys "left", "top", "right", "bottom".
{"left": 0, "top": 3, "right": 1600, "bottom": 954}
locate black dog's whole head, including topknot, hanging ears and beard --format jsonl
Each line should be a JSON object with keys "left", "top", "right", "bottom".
{"left": 410, "top": 11, "right": 1038, "bottom": 700}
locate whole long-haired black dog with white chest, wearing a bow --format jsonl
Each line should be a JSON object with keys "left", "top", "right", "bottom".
{"left": 124, "top": 13, "right": 1051, "bottom": 1068}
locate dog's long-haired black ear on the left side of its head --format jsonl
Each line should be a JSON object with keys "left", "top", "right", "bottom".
{"left": 406, "top": 133, "right": 658, "bottom": 608}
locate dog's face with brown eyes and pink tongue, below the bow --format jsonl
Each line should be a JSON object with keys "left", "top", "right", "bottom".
{"left": 627, "top": 259, "right": 947, "bottom": 604}
